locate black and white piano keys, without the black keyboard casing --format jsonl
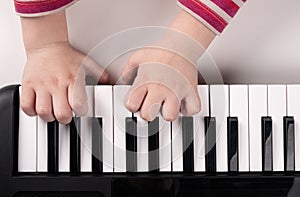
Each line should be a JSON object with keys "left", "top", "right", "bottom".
{"left": 17, "top": 85, "right": 300, "bottom": 174}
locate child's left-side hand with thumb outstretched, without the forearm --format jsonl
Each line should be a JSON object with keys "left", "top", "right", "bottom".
{"left": 21, "top": 42, "right": 109, "bottom": 124}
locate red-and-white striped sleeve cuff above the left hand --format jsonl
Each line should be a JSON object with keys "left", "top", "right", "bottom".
{"left": 14, "top": 0, "right": 76, "bottom": 17}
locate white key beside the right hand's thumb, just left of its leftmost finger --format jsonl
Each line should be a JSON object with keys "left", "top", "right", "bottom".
{"left": 114, "top": 86, "right": 132, "bottom": 172}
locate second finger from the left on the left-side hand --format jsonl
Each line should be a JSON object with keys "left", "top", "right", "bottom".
{"left": 35, "top": 90, "right": 55, "bottom": 122}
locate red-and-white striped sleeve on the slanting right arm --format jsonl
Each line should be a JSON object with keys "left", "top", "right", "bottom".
{"left": 178, "top": 0, "right": 247, "bottom": 35}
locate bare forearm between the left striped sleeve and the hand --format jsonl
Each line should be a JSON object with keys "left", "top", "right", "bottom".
{"left": 21, "top": 11, "right": 68, "bottom": 51}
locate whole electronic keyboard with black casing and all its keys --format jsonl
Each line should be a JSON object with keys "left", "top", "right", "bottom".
{"left": 0, "top": 85, "right": 300, "bottom": 197}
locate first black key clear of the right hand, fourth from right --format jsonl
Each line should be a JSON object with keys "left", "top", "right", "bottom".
{"left": 204, "top": 117, "right": 217, "bottom": 172}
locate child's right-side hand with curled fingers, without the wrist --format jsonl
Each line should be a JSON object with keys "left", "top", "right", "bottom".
{"left": 123, "top": 48, "right": 200, "bottom": 121}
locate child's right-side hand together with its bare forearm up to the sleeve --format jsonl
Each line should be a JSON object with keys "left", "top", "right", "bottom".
{"left": 122, "top": 12, "right": 215, "bottom": 121}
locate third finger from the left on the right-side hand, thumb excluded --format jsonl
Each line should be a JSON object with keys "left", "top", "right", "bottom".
{"left": 162, "top": 95, "right": 180, "bottom": 121}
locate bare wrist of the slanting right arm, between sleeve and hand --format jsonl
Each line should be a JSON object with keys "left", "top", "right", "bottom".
{"left": 150, "top": 11, "right": 216, "bottom": 65}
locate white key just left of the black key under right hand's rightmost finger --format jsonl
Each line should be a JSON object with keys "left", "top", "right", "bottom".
{"left": 172, "top": 116, "right": 183, "bottom": 172}
